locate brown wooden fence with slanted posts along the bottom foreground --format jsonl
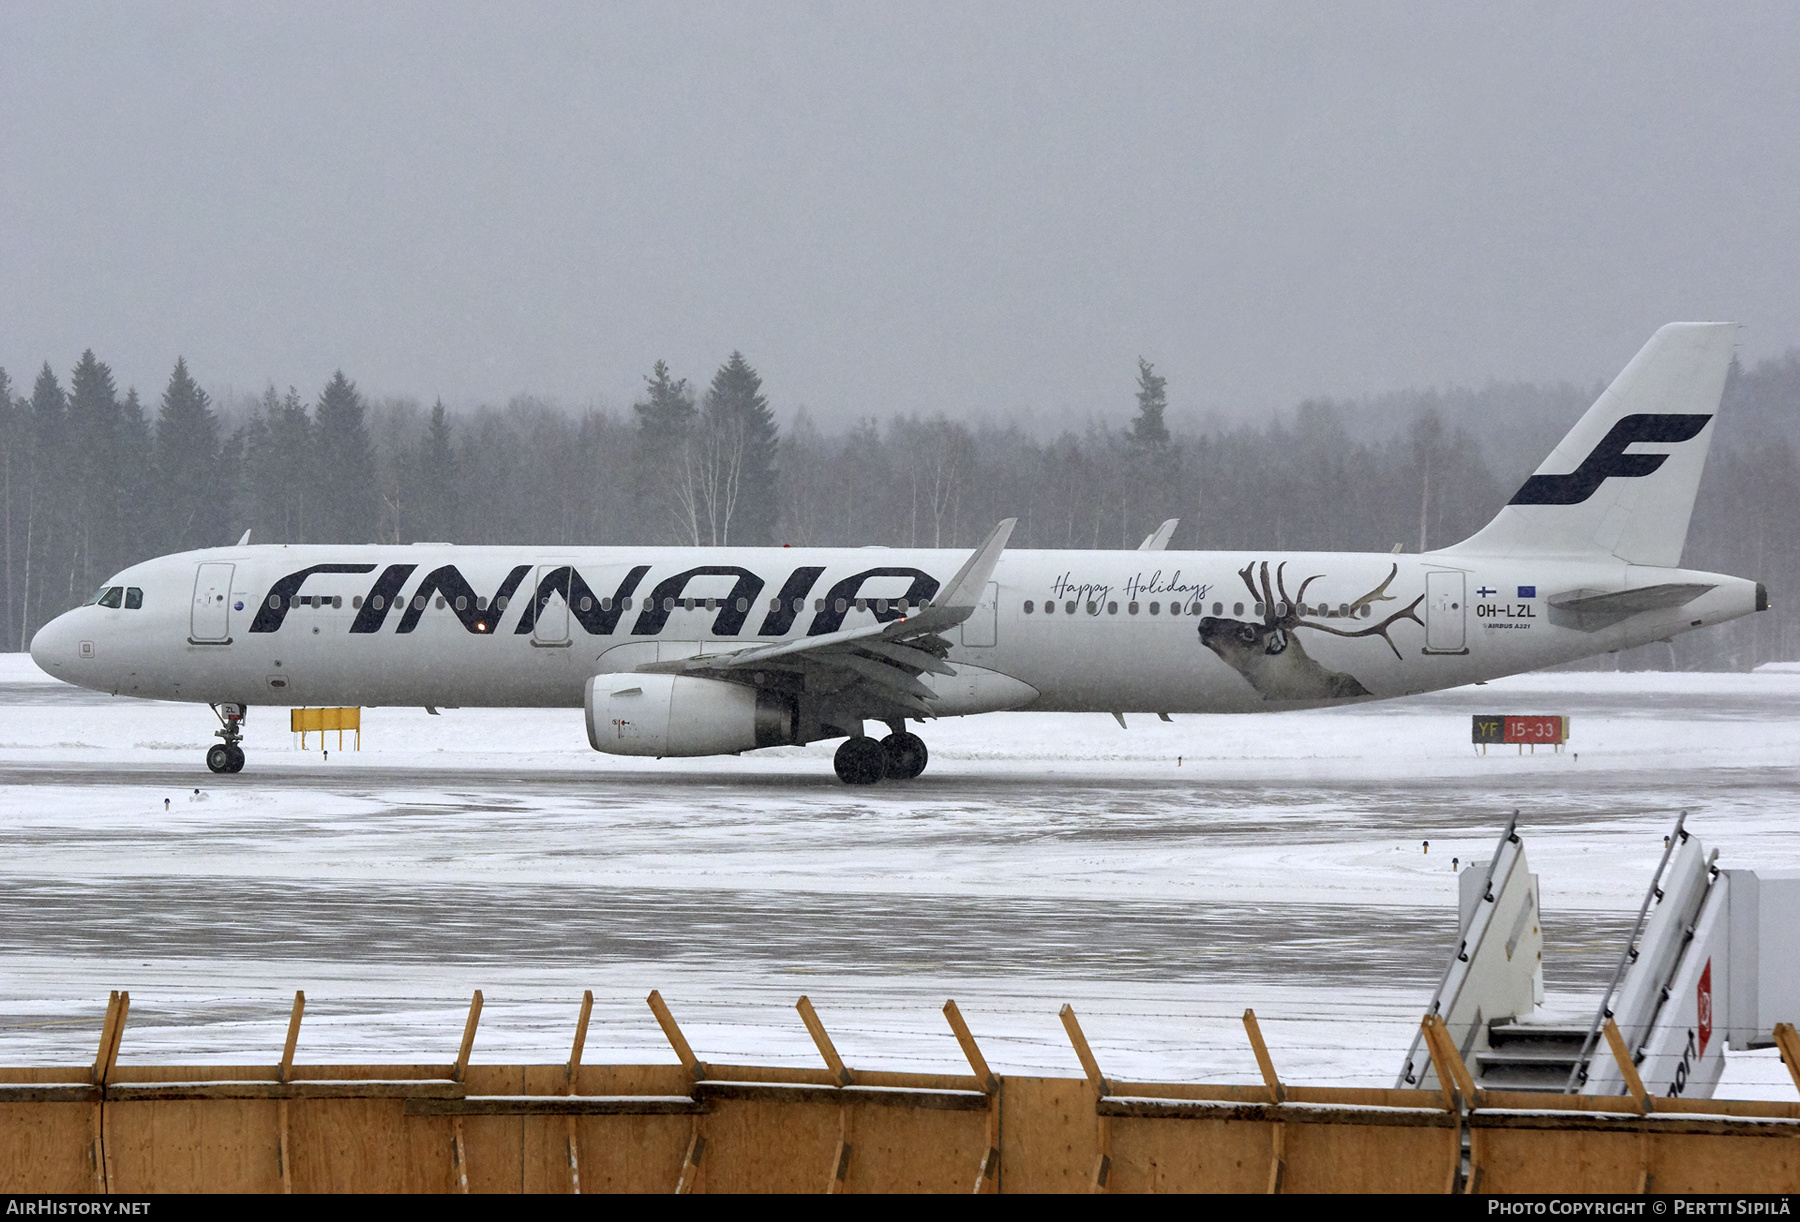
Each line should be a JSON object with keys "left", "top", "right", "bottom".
{"left": 0, "top": 992, "right": 1800, "bottom": 1193}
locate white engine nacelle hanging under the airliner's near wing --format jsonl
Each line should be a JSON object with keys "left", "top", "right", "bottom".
{"left": 587, "top": 673, "right": 799, "bottom": 758}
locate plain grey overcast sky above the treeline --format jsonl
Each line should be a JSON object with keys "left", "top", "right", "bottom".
{"left": 0, "top": 0, "right": 1800, "bottom": 421}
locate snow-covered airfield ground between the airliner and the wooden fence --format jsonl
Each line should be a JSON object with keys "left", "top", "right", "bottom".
{"left": 0, "top": 655, "right": 1800, "bottom": 1098}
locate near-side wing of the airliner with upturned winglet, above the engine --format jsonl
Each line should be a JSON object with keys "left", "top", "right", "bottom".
{"left": 637, "top": 518, "right": 1017, "bottom": 718}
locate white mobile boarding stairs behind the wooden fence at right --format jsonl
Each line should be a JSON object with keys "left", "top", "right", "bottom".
{"left": 1397, "top": 812, "right": 1800, "bottom": 1098}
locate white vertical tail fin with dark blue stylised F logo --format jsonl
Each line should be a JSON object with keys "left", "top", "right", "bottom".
{"left": 1445, "top": 322, "right": 1737, "bottom": 569}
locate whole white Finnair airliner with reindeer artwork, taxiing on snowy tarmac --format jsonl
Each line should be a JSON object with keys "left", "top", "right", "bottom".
{"left": 31, "top": 322, "right": 1768, "bottom": 785}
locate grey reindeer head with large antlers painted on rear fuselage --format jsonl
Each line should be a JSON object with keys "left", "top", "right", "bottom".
{"left": 1201, "top": 560, "right": 1426, "bottom": 700}
